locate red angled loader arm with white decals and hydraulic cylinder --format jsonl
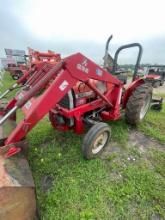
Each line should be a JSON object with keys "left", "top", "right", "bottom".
{"left": 0, "top": 53, "right": 123, "bottom": 156}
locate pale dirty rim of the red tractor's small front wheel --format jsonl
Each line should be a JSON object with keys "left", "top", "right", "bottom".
{"left": 92, "top": 131, "right": 108, "bottom": 154}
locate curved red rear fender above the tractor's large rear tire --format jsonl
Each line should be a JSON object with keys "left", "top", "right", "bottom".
{"left": 122, "top": 79, "right": 145, "bottom": 108}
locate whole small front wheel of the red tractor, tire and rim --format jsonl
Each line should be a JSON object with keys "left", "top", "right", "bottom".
{"left": 82, "top": 122, "right": 111, "bottom": 160}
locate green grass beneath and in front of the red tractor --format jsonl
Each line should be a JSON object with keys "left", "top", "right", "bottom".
{"left": 0, "top": 72, "right": 165, "bottom": 220}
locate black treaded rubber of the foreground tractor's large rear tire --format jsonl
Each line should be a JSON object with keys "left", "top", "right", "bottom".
{"left": 125, "top": 83, "right": 153, "bottom": 125}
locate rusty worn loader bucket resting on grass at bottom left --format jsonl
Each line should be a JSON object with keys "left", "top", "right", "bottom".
{"left": 0, "top": 117, "right": 36, "bottom": 220}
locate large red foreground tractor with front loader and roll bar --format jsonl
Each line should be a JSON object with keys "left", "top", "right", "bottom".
{"left": 0, "top": 37, "right": 152, "bottom": 159}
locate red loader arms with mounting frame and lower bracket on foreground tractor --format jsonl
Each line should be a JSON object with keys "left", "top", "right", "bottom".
{"left": 0, "top": 53, "right": 123, "bottom": 156}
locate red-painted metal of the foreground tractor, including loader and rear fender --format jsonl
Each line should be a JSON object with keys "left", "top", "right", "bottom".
{"left": 0, "top": 53, "right": 144, "bottom": 155}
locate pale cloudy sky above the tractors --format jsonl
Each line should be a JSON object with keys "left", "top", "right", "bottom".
{"left": 0, "top": 0, "right": 165, "bottom": 64}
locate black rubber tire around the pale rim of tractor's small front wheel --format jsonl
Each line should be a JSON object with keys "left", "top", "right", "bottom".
{"left": 82, "top": 122, "right": 111, "bottom": 160}
